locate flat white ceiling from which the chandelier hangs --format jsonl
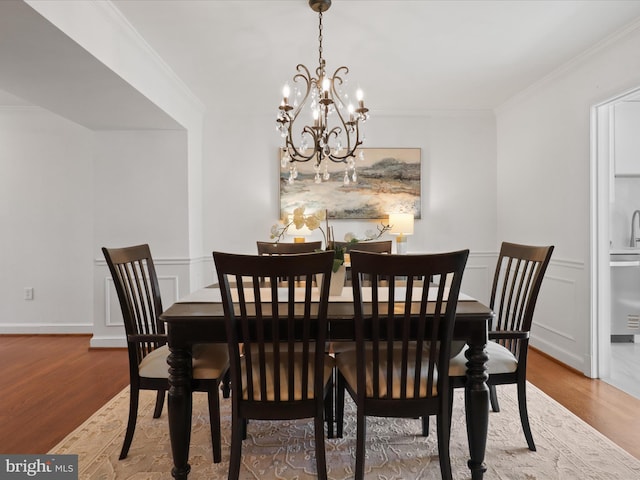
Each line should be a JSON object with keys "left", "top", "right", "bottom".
{"left": 113, "top": 0, "right": 640, "bottom": 113}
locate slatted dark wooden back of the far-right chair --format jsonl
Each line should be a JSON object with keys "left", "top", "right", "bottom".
{"left": 490, "top": 242, "right": 553, "bottom": 356}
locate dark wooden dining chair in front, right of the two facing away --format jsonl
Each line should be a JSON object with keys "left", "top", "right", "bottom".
{"left": 336, "top": 250, "right": 469, "bottom": 480}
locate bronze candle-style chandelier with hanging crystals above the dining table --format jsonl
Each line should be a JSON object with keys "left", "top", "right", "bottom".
{"left": 277, "top": 0, "right": 369, "bottom": 185}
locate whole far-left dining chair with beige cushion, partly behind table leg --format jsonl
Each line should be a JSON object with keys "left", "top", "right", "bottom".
{"left": 102, "top": 244, "right": 229, "bottom": 463}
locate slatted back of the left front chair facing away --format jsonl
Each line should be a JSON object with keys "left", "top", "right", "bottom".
{"left": 213, "top": 252, "right": 333, "bottom": 404}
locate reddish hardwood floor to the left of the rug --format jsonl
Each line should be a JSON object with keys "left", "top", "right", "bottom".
{"left": 0, "top": 335, "right": 129, "bottom": 454}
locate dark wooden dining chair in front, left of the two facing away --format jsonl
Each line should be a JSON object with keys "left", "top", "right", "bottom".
{"left": 213, "top": 251, "right": 333, "bottom": 480}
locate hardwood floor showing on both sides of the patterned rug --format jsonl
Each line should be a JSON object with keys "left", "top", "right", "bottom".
{"left": 0, "top": 335, "right": 640, "bottom": 459}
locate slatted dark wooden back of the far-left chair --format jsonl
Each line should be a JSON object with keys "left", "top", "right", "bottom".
{"left": 102, "top": 244, "right": 166, "bottom": 365}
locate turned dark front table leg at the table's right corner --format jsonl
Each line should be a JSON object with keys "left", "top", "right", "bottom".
{"left": 464, "top": 331, "right": 489, "bottom": 480}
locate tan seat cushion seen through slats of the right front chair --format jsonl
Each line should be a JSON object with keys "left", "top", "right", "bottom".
{"left": 336, "top": 348, "right": 438, "bottom": 398}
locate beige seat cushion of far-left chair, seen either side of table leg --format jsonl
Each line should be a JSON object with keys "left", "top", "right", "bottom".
{"left": 138, "top": 343, "right": 229, "bottom": 380}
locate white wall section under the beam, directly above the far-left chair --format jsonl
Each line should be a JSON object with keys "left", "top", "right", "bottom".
{"left": 93, "top": 130, "right": 189, "bottom": 258}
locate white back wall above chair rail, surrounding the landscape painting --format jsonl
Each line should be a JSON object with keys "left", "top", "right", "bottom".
{"left": 203, "top": 112, "right": 497, "bottom": 296}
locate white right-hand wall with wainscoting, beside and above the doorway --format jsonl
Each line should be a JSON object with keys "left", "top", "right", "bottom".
{"left": 497, "top": 23, "right": 640, "bottom": 375}
